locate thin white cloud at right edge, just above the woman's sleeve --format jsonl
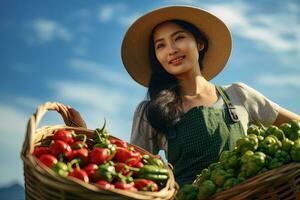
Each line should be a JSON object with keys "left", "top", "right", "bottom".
{"left": 255, "top": 74, "right": 300, "bottom": 89}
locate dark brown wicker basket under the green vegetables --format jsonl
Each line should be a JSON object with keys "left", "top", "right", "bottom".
{"left": 209, "top": 163, "right": 300, "bottom": 200}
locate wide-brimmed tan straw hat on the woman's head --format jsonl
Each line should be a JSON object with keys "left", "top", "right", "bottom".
{"left": 121, "top": 6, "right": 232, "bottom": 87}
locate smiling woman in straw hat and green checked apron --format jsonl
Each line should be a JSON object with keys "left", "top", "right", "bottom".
{"left": 68, "top": 6, "right": 300, "bottom": 185}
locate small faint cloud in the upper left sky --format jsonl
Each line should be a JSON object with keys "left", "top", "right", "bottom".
{"left": 30, "top": 18, "right": 72, "bottom": 43}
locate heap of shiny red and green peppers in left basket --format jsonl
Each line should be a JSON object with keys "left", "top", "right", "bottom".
{"left": 32, "top": 124, "right": 168, "bottom": 192}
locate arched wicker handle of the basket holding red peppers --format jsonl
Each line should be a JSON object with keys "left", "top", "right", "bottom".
{"left": 21, "top": 102, "right": 78, "bottom": 157}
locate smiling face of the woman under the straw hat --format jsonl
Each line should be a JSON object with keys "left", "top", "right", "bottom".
{"left": 153, "top": 22, "right": 204, "bottom": 76}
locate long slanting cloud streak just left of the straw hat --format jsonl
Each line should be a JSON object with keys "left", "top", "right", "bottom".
{"left": 69, "top": 59, "right": 137, "bottom": 87}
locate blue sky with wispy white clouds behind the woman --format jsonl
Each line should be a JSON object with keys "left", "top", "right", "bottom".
{"left": 0, "top": 0, "right": 300, "bottom": 186}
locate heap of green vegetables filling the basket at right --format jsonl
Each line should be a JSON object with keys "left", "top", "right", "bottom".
{"left": 177, "top": 120, "right": 300, "bottom": 200}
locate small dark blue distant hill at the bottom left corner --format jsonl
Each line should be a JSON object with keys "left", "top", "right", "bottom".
{"left": 0, "top": 183, "right": 25, "bottom": 200}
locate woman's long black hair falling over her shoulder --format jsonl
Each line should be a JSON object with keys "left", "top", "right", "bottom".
{"left": 143, "top": 20, "right": 208, "bottom": 133}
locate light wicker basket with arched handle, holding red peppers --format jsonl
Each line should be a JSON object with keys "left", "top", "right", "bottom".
{"left": 21, "top": 102, "right": 178, "bottom": 200}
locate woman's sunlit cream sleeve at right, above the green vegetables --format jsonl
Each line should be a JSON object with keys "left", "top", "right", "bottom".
{"left": 235, "top": 83, "right": 280, "bottom": 126}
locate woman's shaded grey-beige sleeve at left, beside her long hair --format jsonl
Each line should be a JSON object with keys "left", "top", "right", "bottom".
{"left": 130, "top": 101, "right": 159, "bottom": 154}
